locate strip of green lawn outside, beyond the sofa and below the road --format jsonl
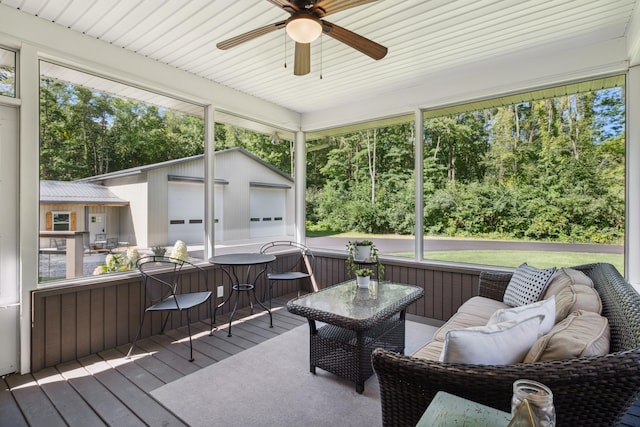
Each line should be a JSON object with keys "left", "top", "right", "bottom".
{"left": 394, "top": 250, "right": 624, "bottom": 272}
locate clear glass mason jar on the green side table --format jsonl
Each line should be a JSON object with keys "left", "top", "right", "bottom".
{"left": 511, "top": 379, "right": 556, "bottom": 427}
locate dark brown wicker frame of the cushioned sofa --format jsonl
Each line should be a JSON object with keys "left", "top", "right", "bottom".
{"left": 372, "top": 263, "right": 640, "bottom": 426}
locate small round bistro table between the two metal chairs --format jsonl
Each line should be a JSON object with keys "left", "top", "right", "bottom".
{"left": 209, "top": 253, "right": 276, "bottom": 337}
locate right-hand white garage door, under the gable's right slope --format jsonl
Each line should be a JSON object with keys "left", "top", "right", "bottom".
{"left": 249, "top": 187, "right": 287, "bottom": 237}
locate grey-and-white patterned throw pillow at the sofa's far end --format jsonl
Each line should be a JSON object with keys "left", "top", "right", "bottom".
{"left": 502, "top": 262, "right": 556, "bottom": 307}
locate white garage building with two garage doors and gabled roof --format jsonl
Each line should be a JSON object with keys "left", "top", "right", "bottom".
{"left": 82, "top": 148, "right": 294, "bottom": 248}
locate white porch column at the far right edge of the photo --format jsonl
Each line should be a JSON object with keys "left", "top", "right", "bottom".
{"left": 624, "top": 65, "right": 640, "bottom": 290}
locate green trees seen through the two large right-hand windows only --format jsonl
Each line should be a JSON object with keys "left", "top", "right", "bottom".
{"left": 307, "top": 88, "right": 625, "bottom": 243}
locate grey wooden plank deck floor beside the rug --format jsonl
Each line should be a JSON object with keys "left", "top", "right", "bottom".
{"left": 5, "top": 295, "right": 640, "bottom": 427}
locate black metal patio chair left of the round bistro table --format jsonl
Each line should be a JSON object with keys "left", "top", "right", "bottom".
{"left": 126, "top": 255, "right": 213, "bottom": 362}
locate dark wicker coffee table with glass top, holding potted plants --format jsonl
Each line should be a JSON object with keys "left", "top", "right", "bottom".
{"left": 287, "top": 280, "right": 424, "bottom": 393}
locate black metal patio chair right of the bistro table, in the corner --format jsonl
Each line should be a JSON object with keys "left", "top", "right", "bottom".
{"left": 260, "top": 240, "right": 318, "bottom": 309}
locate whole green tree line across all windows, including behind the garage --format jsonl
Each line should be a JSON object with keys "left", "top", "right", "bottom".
{"left": 40, "top": 79, "right": 625, "bottom": 243}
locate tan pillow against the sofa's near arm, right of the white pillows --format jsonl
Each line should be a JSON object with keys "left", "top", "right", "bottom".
{"left": 524, "top": 310, "right": 610, "bottom": 363}
